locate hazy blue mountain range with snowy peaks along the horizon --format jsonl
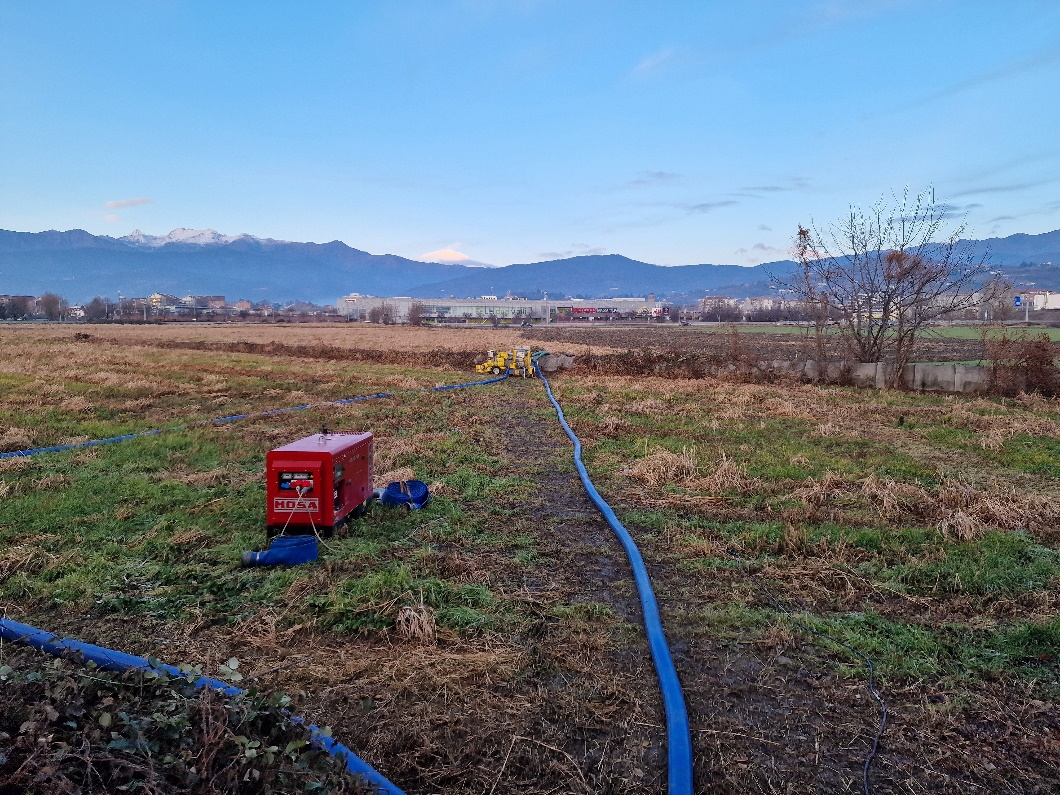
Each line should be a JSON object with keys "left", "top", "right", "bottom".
{"left": 0, "top": 229, "right": 1060, "bottom": 303}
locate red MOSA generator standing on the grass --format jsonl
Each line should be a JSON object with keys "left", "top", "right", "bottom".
{"left": 265, "top": 430, "right": 372, "bottom": 536}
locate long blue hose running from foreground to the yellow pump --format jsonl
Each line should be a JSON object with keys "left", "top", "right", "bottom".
{"left": 540, "top": 372, "right": 692, "bottom": 795}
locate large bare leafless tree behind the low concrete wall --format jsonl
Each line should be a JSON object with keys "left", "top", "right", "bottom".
{"left": 774, "top": 190, "right": 996, "bottom": 386}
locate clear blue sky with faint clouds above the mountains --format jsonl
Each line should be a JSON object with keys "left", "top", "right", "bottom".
{"left": 0, "top": 0, "right": 1060, "bottom": 265}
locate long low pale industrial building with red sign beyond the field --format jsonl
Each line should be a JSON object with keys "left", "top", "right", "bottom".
{"left": 335, "top": 293, "right": 666, "bottom": 323}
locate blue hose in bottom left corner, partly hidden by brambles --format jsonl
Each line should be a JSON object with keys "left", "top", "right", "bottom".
{"left": 0, "top": 618, "right": 405, "bottom": 795}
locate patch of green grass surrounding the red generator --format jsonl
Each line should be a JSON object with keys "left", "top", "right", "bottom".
{"left": 0, "top": 357, "right": 555, "bottom": 633}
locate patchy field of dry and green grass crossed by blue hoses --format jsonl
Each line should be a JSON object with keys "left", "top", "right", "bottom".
{"left": 0, "top": 324, "right": 1060, "bottom": 795}
